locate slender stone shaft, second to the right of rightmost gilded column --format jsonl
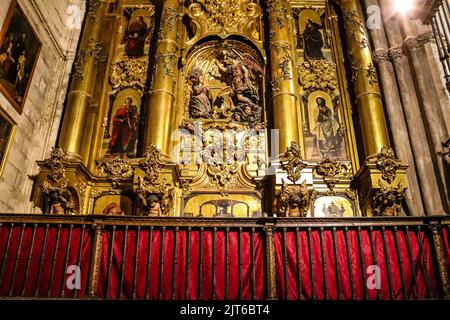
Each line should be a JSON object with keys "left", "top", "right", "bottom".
{"left": 380, "top": 1, "right": 444, "bottom": 215}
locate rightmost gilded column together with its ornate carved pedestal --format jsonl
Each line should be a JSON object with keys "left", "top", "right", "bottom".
{"left": 336, "top": 0, "right": 408, "bottom": 216}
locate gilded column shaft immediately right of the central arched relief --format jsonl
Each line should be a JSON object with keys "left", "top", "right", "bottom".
{"left": 267, "top": 0, "right": 301, "bottom": 152}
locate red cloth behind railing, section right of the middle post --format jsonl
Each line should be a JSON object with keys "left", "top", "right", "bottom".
{"left": 275, "top": 230, "right": 438, "bottom": 300}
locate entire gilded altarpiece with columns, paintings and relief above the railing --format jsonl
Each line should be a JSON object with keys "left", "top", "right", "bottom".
{"left": 30, "top": 0, "right": 405, "bottom": 218}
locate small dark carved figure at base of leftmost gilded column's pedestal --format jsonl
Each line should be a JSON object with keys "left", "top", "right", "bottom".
{"left": 43, "top": 181, "right": 74, "bottom": 214}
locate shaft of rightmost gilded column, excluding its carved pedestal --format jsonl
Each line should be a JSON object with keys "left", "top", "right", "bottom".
{"left": 336, "top": 0, "right": 389, "bottom": 156}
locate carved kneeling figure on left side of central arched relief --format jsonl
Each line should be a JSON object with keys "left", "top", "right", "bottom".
{"left": 189, "top": 69, "right": 213, "bottom": 119}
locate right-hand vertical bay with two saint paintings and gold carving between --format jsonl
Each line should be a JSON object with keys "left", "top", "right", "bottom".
{"left": 293, "top": 4, "right": 355, "bottom": 161}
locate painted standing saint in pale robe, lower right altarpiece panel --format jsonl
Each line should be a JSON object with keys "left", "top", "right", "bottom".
{"left": 312, "top": 97, "right": 342, "bottom": 157}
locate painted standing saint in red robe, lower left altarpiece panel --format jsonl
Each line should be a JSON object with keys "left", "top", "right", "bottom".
{"left": 106, "top": 97, "right": 139, "bottom": 156}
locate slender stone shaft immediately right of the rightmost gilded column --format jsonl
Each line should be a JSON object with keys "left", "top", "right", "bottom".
{"left": 365, "top": 0, "right": 425, "bottom": 215}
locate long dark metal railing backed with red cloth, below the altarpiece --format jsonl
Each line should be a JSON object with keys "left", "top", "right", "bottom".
{"left": 0, "top": 215, "right": 450, "bottom": 300}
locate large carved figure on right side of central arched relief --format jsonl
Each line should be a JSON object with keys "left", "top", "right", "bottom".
{"left": 215, "top": 50, "right": 263, "bottom": 123}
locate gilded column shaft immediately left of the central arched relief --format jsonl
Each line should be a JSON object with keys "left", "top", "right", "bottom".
{"left": 144, "top": 0, "right": 183, "bottom": 155}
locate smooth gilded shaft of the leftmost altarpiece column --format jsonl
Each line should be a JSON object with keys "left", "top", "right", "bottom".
{"left": 59, "top": 0, "right": 107, "bottom": 164}
